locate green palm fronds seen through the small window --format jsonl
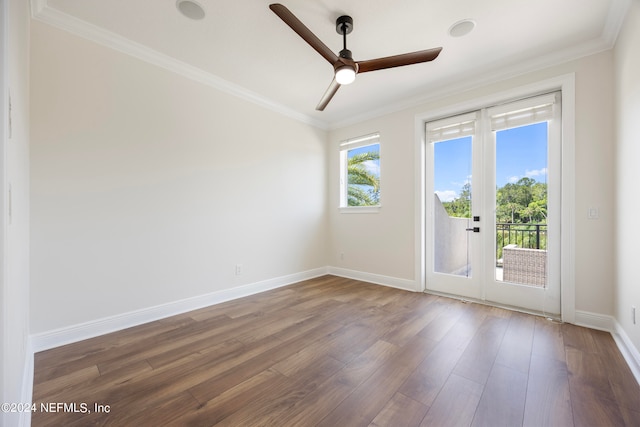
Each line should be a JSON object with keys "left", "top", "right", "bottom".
{"left": 347, "top": 151, "right": 380, "bottom": 206}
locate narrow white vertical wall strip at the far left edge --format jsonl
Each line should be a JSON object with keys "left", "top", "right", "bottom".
{"left": 0, "top": 0, "right": 33, "bottom": 426}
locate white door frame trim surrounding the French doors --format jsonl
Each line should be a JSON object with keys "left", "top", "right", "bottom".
{"left": 414, "top": 73, "right": 576, "bottom": 323}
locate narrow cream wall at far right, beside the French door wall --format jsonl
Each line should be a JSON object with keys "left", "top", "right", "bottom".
{"left": 614, "top": 1, "right": 640, "bottom": 363}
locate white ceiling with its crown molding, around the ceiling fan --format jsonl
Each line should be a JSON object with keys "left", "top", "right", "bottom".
{"left": 31, "top": 0, "right": 630, "bottom": 128}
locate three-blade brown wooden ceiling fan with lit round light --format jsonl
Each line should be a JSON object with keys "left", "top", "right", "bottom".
{"left": 269, "top": 3, "right": 442, "bottom": 111}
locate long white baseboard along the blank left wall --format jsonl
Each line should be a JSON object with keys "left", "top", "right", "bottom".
{"left": 31, "top": 267, "right": 328, "bottom": 352}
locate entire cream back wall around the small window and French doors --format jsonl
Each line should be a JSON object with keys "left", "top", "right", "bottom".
{"left": 329, "top": 52, "right": 615, "bottom": 315}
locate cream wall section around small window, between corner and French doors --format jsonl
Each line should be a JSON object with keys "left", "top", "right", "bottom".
{"left": 328, "top": 112, "right": 415, "bottom": 280}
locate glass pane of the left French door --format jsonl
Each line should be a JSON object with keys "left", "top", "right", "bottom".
{"left": 433, "top": 136, "right": 472, "bottom": 277}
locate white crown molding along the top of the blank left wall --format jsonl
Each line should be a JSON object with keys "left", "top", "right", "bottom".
{"left": 31, "top": 0, "right": 328, "bottom": 130}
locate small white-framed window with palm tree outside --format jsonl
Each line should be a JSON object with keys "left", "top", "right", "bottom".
{"left": 340, "top": 133, "right": 380, "bottom": 208}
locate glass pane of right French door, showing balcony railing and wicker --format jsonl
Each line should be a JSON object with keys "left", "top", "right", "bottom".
{"left": 495, "top": 122, "right": 548, "bottom": 287}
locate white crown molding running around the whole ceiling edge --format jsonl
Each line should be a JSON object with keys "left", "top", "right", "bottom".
{"left": 31, "top": 0, "right": 632, "bottom": 130}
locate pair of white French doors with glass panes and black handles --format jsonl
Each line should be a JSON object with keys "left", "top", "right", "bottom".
{"left": 425, "top": 92, "right": 561, "bottom": 316}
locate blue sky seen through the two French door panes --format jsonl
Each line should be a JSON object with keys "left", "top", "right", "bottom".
{"left": 434, "top": 122, "right": 547, "bottom": 202}
